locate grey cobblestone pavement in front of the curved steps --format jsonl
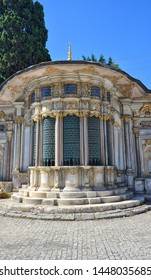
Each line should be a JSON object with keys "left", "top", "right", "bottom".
{"left": 0, "top": 211, "right": 151, "bottom": 260}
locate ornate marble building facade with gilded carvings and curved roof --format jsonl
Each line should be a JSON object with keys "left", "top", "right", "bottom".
{"left": 0, "top": 61, "right": 151, "bottom": 202}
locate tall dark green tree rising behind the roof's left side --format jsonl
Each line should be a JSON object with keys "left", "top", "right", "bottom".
{"left": 0, "top": 0, "right": 51, "bottom": 82}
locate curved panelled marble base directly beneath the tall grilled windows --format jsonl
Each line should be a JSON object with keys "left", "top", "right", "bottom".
{"left": 29, "top": 166, "right": 116, "bottom": 192}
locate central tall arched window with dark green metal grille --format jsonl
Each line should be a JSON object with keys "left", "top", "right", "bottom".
{"left": 63, "top": 115, "right": 80, "bottom": 165}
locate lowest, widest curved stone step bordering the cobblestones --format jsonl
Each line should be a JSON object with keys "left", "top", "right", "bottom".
{"left": 0, "top": 194, "right": 147, "bottom": 221}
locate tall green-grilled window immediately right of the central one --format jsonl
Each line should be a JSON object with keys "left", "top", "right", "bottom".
{"left": 88, "top": 117, "right": 101, "bottom": 165}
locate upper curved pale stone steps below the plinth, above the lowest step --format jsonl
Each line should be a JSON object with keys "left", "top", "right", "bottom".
{"left": 11, "top": 187, "right": 144, "bottom": 212}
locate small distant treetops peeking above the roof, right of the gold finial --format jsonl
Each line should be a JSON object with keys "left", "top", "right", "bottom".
{"left": 82, "top": 54, "right": 119, "bottom": 69}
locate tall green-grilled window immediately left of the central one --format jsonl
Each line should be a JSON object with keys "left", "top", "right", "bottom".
{"left": 42, "top": 117, "right": 55, "bottom": 166}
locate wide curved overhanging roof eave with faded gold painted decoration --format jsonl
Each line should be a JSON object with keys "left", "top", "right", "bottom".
{"left": 0, "top": 60, "right": 151, "bottom": 103}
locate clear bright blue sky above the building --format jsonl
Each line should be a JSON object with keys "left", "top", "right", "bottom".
{"left": 39, "top": 0, "right": 151, "bottom": 89}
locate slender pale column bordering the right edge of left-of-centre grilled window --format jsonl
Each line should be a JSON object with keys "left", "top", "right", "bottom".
{"left": 55, "top": 115, "right": 60, "bottom": 166}
